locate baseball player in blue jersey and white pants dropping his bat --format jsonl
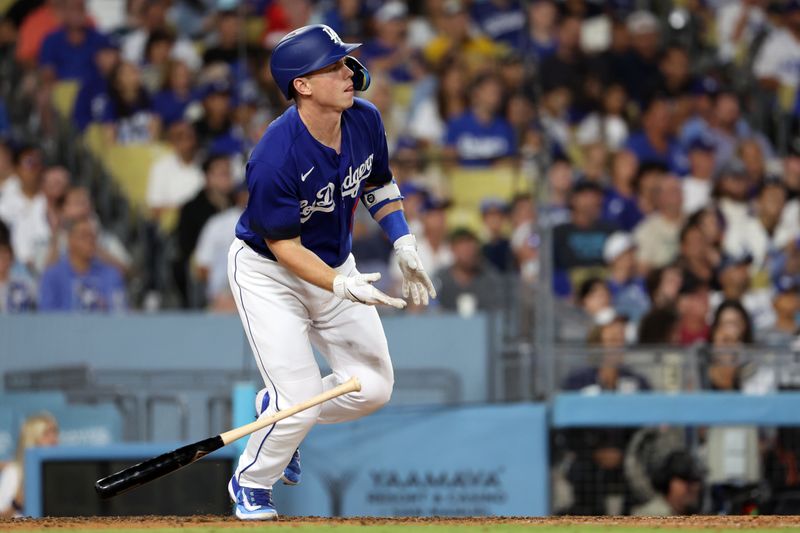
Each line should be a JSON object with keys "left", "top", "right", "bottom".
{"left": 228, "top": 24, "right": 436, "bottom": 520}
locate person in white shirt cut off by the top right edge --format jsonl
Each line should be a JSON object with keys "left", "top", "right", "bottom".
{"left": 753, "top": 0, "right": 800, "bottom": 91}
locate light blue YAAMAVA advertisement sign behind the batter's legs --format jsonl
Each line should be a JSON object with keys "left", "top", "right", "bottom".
{"left": 267, "top": 404, "right": 548, "bottom": 516}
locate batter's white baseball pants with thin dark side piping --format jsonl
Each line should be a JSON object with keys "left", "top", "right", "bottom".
{"left": 228, "top": 239, "right": 394, "bottom": 488}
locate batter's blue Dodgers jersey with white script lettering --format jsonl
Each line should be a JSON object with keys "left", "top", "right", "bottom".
{"left": 236, "top": 98, "right": 392, "bottom": 267}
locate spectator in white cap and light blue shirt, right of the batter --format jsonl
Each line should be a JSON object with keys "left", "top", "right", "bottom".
{"left": 603, "top": 232, "right": 650, "bottom": 324}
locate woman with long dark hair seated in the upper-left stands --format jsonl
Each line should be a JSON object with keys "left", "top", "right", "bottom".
{"left": 101, "top": 61, "right": 160, "bottom": 144}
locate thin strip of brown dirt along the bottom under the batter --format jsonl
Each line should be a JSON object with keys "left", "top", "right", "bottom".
{"left": 0, "top": 515, "right": 800, "bottom": 531}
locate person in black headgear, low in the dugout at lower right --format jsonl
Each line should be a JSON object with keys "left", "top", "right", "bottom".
{"left": 631, "top": 450, "right": 703, "bottom": 516}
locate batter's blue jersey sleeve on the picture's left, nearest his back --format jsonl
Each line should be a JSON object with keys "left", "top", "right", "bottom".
{"left": 246, "top": 160, "right": 300, "bottom": 240}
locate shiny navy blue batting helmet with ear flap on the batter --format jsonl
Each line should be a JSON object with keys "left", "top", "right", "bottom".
{"left": 269, "top": 24, "right": 370, "bottom": 99}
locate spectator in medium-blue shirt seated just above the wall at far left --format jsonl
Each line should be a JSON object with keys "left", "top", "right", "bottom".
{"left": 39, "top": 217, "right": 126, "bottom": 313}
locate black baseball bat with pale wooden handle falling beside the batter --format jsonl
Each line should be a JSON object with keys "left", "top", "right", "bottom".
{"left": 94, "top": 377, "right": 361, "bottom": 499}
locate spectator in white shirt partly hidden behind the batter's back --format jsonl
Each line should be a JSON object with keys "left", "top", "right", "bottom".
{"left": 193, "top": 182, "right": 249, "bottom": 313}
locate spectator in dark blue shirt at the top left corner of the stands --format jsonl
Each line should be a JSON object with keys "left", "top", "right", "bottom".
{"left": 39, "top": 0, "right": 107, "bottom": 82}
